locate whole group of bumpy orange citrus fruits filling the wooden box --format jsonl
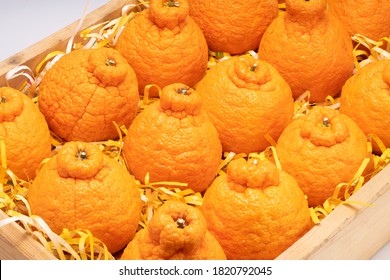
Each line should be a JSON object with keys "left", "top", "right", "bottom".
{"left": 0, "top": 0, "right": 390, "bottom": 260}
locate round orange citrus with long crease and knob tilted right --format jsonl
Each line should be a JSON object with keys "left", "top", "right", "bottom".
{"left": 38, "top": 48, "right": 139, "bottom": 142}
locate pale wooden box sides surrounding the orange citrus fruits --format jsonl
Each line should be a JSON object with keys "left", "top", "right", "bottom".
{"left": 0, "top": 0, "right": 390, "bottom": 260}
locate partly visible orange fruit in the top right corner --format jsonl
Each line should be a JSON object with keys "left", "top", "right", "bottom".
{"left": 328, "top": 0, "right": 390, "bottom": 40}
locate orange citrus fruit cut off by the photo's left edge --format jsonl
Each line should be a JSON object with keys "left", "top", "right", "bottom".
{"left": 0, "top": 87, "right": 51, "bottom": 180}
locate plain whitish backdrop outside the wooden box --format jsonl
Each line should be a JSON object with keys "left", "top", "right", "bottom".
{"left": 0, "top": 0, "right": 390, "bottom": 260}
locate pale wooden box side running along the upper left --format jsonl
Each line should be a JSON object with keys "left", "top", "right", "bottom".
{"left": 0, "top": 0, "right": 138, "bottom": 88}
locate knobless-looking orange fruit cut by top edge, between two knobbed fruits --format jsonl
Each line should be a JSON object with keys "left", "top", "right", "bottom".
{"left": 188, "top": 0, "right": 278, "bottom": 54}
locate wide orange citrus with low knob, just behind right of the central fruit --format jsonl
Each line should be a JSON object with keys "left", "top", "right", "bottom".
{"left": 196, "top": 56, "right": 294, "bottom": 154}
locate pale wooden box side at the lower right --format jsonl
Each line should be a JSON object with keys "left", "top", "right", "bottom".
{"left": 278, "top": 166, "right": 390, "bottom": 260}
